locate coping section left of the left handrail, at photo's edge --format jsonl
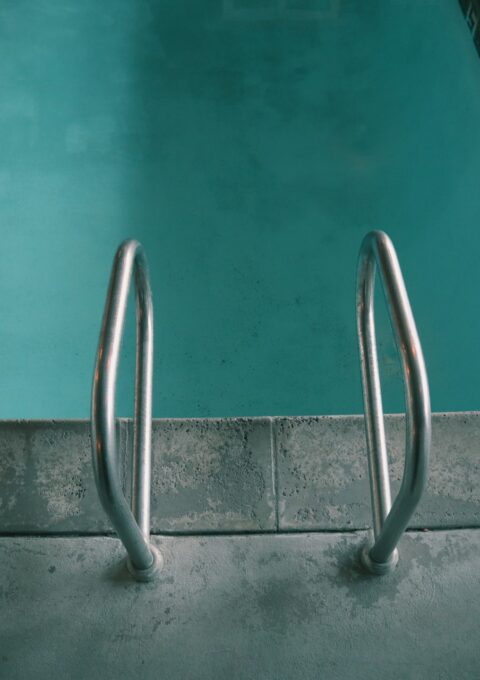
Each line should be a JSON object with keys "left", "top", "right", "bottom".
{"left": 0, "top": 421, "right": 122, "bottom": 533}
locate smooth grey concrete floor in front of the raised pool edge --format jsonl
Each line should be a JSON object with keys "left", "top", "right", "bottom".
{"left": 0, "top": 530, "right": 480, "bottom": 680}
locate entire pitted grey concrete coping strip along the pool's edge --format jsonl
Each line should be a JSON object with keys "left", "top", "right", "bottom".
{"left": 0, "top": 413, "right": 480, "bottom": 533}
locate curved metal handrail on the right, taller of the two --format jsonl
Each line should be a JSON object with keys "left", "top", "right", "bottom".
{"left": 357, "top": 231, "right": 431, "bottom": 574}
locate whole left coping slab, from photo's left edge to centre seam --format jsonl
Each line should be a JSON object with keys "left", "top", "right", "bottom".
{"left": 0, "top": 418, "right": 276, "bottom": 533}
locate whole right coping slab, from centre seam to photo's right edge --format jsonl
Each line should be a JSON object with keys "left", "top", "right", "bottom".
{"left": 274, "top": 413, "right": 480, "bottom": 530}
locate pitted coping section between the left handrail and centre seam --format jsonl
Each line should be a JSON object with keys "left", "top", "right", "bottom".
{"left": 141, "top": 418, "right": 275, "bottom": 533}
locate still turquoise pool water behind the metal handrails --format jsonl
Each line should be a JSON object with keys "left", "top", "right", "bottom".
{"left": 0, "top": 0, "right": 480, "bottom": 418}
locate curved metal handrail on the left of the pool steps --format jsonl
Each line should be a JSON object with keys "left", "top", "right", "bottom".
{"left": 92, "top": 240, "right": 162, "bottom": 581}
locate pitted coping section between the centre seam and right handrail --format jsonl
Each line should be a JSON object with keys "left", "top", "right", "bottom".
{"left": 274, "top": 417, "right": 370, "bottom": 530}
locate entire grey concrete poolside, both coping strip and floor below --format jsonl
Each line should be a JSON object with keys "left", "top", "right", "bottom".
{"left": 0, "top": 413, "right": 480, "bottom": 680}
